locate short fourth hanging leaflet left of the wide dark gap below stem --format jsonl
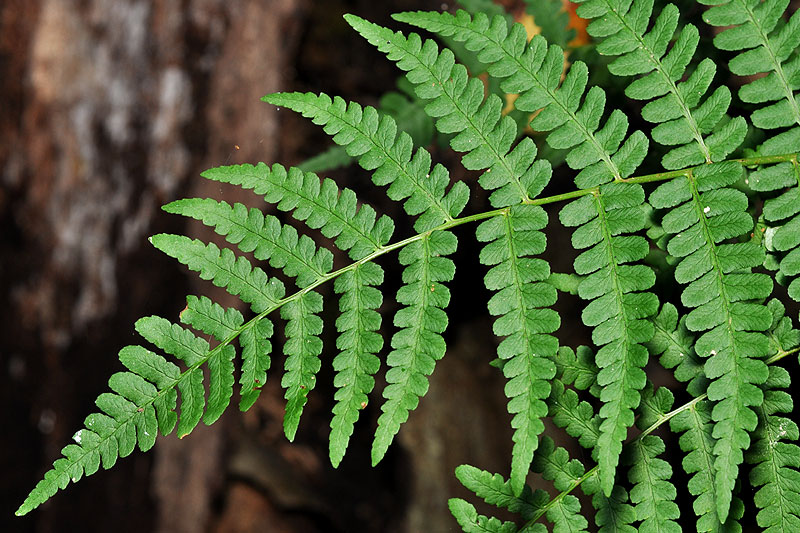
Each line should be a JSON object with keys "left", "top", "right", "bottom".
{"left": 239, "top": 318, "right": 273, "bottom": 411}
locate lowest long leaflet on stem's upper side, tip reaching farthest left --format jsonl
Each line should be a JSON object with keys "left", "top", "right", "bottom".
{"left": 150, "top": 233, "right": 285, "bottom": 313}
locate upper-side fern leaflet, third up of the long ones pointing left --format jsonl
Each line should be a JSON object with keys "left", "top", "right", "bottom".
{"left": 202, "top": 163, "right": 394, "bottom": 261}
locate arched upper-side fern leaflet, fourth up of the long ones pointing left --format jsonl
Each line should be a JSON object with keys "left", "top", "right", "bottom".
{"left": 263, "top": 93, "right": 469, "bottom": 232}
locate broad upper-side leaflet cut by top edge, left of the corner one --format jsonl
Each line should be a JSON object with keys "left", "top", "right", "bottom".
{"left": 576, "top": 0, "right": 747, "bottom": 169}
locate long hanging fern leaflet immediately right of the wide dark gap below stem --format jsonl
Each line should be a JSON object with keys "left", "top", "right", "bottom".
{"left": 477, "top": 205, "right": 561, "bottom": 494}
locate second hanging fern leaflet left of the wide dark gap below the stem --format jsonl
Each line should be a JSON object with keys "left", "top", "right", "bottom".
{"left": 330, "top": 263, "right": 383, "bottom": 467}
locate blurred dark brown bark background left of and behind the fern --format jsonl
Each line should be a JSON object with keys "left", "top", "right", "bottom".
{"left": 0, "top": 0, "right": 524, "bottom": 532}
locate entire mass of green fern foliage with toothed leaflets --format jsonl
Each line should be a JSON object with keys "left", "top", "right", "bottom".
{"left": 18, "top": 0, "right": 800, "bottom": 532}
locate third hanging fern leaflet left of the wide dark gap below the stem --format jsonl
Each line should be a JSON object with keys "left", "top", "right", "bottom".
{"left": 281, "top": 291, "right": 322, "bottom": 441}
